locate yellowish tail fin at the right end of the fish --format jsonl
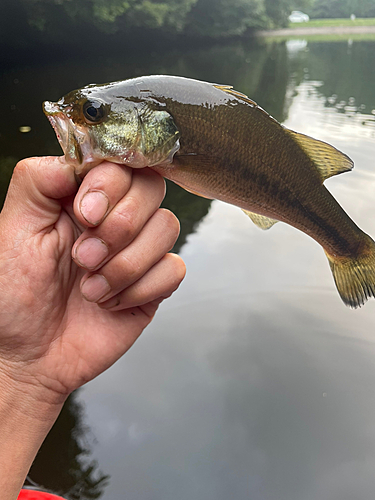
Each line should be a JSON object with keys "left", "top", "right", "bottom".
{"left": 326, "top": 235, "right": 375, "bottom": 308}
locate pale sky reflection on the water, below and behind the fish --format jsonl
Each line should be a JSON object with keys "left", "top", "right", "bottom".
{"left": 82, "top": 40, "right": 375, "bottom": 500}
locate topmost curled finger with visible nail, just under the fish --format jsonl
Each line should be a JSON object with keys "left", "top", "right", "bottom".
{"left": 73, "top": 161, "right": 132, "bottom": 227}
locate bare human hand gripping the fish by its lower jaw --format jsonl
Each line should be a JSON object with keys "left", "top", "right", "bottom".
{"left": 0, "top": 158, "right": 185, "bottom": 413}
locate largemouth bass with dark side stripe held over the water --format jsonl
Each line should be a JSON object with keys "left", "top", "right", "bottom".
{"left": 43, "top": 75, "right": 375, "bottom": 308}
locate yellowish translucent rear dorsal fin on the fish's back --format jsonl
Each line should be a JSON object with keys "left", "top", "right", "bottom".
{"left": 285, "top": 128, "right": 354, "bottom": 182}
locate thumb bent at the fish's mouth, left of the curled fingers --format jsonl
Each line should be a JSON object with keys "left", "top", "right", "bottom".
{"left": 1, "top": 156, "right": 78, "bottom": 234}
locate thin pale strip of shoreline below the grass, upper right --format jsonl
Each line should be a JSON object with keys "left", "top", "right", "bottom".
{"left": 255, "top": 26, "right": 375, "bottom": 37}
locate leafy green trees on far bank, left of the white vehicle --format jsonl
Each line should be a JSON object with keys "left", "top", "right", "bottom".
{"left": 18, "top": 0, "right": 312, "bottom": 37}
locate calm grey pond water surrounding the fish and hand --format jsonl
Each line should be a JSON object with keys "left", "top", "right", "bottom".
{"left": 0, "top": 35, "right": 375, "bottom": 500}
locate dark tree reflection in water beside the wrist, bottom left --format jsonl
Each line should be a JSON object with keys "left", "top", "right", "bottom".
{"left": 29, "top": 391, "right": 109, "bottom": 500}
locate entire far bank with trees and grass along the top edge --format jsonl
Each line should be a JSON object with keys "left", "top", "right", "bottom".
{"left": 5, "top": 0, "right": 375, "bottom": 46}
